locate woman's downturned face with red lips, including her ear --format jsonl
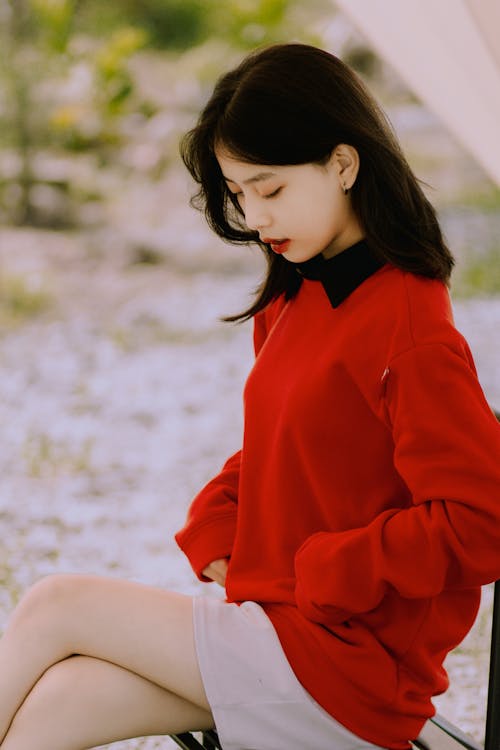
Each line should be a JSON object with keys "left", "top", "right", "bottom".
{"left": 217, "top": 147, "right": 364, "bottom": 263}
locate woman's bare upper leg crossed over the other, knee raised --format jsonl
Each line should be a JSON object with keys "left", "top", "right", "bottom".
{"left": 0, "top": 575, "right": 210, "bottom": 739}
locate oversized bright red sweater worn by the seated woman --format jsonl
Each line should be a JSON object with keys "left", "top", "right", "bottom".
{"left": 176, "top": 250, "right": 500, "bottom": 750}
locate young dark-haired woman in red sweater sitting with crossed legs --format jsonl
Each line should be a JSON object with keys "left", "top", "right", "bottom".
{"left": 0, "top": 44, "right": 500, "bottom": 750}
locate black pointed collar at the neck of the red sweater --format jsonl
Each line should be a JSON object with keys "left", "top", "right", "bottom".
{"left": 292, "top": 240, "right": 384, "bottom": 307}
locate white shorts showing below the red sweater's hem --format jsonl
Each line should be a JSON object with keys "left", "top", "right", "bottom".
{"left": 193, "top": 596, "right": 377, "bottom": 750}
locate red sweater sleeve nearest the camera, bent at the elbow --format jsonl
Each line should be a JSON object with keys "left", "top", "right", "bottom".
{"left": 296, "top": 337, "right": 500, "bottom": 624}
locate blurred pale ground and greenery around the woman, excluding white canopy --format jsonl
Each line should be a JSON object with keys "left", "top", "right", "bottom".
{"left": 0, "top": 0, "right": 500, "bottom": 748}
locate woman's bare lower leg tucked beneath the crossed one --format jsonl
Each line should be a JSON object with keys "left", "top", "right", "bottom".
{"left": 1, "top": 656, "right": 213, "bottom": 750}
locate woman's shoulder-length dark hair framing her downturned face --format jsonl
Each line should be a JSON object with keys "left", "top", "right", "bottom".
{"left": 180, "top": 44, "right": 454, "bottom": 320}
